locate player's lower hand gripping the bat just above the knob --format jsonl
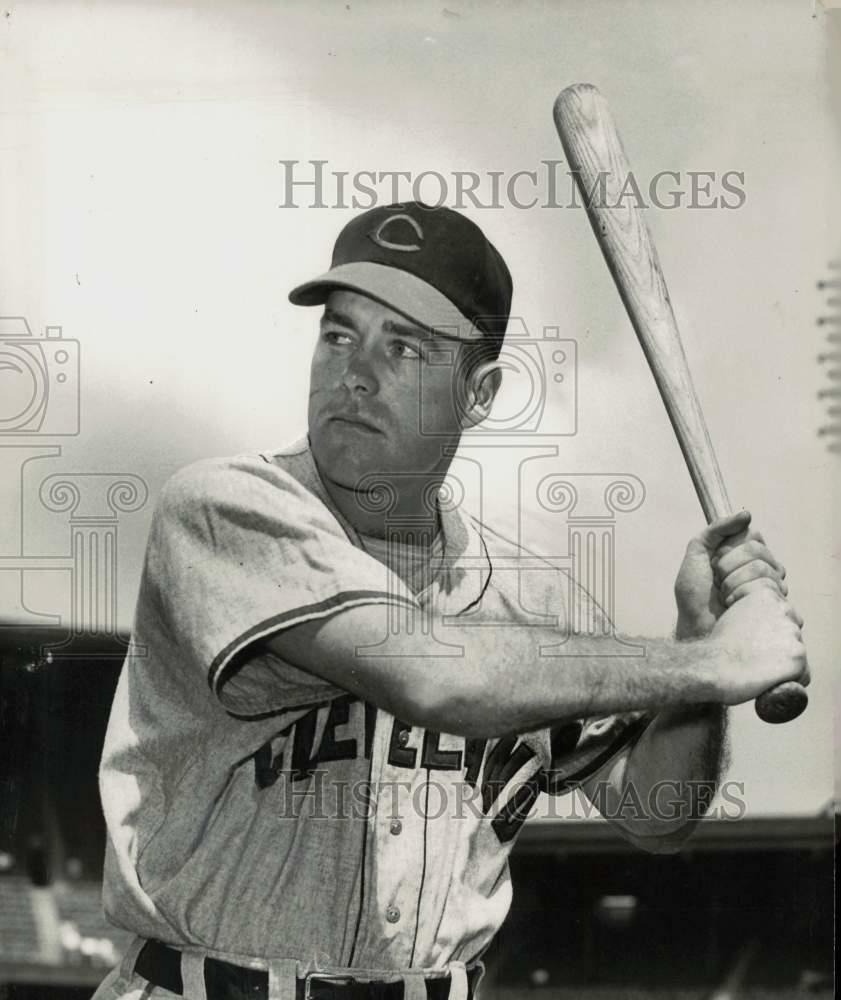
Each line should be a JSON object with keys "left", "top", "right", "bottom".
{"left": 710, "top": 581, "right": 809, "bottom": 705}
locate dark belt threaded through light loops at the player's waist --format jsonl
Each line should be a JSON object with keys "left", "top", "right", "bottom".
{"left": 134, "top": 941, "right": 481, "bottom": 1000}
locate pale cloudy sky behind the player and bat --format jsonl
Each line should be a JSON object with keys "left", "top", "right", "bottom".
{"left": 0, "top": 0, "right": 839, "bottom": 814}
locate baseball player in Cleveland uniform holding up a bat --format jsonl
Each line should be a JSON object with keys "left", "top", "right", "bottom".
{"left": 96, "top": 203, "right": 808, "bottom": 1000}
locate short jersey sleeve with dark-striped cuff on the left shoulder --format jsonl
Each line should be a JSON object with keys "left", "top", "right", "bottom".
{"left": 139, "top": 456, "right": 416, "bottom": 718}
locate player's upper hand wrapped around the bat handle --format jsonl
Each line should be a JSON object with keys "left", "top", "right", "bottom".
{"left": 675, "top": 511, "right": 788, "bottom": 639}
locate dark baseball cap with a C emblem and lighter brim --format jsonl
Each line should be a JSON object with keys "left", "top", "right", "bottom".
{"left": 289, "top": 201, "right": 513, "bottom": 345}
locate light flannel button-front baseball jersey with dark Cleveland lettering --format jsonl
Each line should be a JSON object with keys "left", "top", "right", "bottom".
{"left": 100, "top": 440, "right": 648, "bottom": 970}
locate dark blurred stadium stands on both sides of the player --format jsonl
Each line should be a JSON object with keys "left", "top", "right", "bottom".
{"left": 0, "top": 627, "right": 836, "bottom": 1000}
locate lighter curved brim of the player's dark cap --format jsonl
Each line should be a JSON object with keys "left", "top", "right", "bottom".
{"left": 289, "top": 261, "right": 484, "bottom": 340}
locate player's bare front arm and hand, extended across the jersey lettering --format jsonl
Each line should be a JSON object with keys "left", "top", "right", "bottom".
{"left": 269, "top": 590, "right": 805, "bottom": 737}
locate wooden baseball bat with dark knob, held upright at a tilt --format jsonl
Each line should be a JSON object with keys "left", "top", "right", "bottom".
{"left": 554, "top": 83, "right": 808, "bottom": 722}
